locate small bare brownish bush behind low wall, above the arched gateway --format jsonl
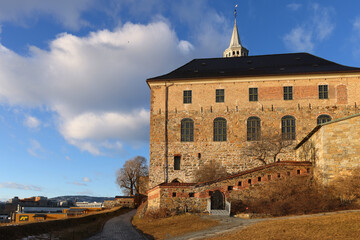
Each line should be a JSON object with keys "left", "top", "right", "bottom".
{"left": 194, "top": 160, "right": 228, "bottom": 182}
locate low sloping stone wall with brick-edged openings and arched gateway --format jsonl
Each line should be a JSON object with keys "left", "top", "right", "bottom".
{"left": 148, "top": 162, "right": 312, "bottom": 212}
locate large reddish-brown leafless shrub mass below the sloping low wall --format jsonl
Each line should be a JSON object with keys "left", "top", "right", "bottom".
{"left": 236, "top": 176, "right": 348, "bottom": 216}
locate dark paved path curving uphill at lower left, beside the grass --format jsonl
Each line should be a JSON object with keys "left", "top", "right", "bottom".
{"left": 88, "top": 209, "right": 147, "bottom": 240}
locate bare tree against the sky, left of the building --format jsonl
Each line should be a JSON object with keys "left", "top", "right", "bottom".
{"left": 116, "top": 156, "right": 149, "bottom": 196}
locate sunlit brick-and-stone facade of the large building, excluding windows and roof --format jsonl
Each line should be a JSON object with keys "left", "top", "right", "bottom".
{"left": 149, "top": 74, "right": 360, "bottom": 188}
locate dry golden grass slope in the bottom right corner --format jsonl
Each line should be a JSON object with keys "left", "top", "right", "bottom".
{"left": 207, "top": 212, "right": 360, "bottom": 240}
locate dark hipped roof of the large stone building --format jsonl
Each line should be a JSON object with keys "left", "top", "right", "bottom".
{"left": 147, "top": 53, "right": 360, "bottom": 82}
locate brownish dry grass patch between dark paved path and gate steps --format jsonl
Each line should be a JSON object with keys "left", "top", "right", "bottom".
{"left": 132, "top": 214, "right": 219, "bottom": 239}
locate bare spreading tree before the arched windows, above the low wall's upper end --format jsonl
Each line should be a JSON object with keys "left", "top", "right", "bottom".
{"left": 242, "top": 132, "right": 293, "bottom": 165}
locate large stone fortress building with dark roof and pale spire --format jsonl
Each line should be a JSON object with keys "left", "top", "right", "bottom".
{"left": 147, "top": 14, "right": 360, "bottom": 191}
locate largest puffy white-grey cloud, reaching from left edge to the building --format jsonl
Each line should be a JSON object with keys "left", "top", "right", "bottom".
{"left": 0, "top": 21, "right": 192, "bottom": 155}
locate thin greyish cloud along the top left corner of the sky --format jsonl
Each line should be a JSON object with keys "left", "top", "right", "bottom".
{"left": 0, "top": 0, "right": 95, "bottom": 29}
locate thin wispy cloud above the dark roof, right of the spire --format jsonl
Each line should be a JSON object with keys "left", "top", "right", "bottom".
{"left": 283, "top": 4, "right": 335, "bottom": 51}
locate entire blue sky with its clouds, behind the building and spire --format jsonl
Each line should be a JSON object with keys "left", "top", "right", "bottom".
{"left": 0, "top": 0, "right": 360, "bottom": 200}
